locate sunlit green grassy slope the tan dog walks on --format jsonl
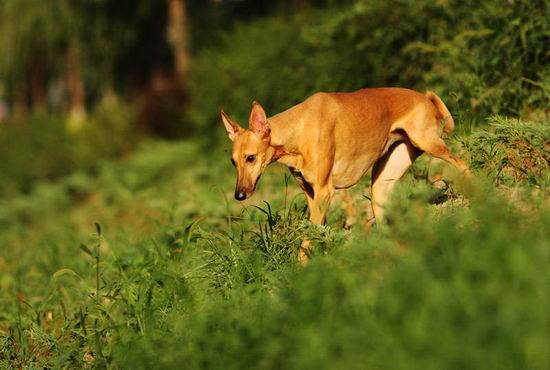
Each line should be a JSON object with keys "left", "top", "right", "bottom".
{"left": 0, "top": 117, "right": 550, "bottom": 369}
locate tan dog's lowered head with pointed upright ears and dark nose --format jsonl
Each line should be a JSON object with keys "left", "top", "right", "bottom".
{"left": 221, "top": 102, "right": 273, "bottom": 200}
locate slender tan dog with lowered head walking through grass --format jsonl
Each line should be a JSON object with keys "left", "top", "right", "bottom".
{"left": 221, "top": 88, "right": 468, "bottom": 260}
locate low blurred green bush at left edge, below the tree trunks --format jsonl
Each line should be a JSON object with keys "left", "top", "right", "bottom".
{"left": 0, "top": 104, "right": 138, "bottom": 198}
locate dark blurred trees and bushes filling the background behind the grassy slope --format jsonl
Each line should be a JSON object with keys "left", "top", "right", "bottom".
{"left": 0, "top": 0, "right": 550, "bottom": 196}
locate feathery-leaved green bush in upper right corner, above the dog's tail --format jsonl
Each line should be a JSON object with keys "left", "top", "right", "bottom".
{"left": 407, "top": 0, "right": 550, "bottom": 119}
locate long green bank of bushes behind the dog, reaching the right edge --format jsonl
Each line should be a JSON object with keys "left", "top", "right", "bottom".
{"left": 189, "top": 0, "right": 550, "bottom": 136}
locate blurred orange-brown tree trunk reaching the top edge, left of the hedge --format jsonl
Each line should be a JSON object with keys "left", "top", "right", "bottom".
{"left": 168, "top": 0, "right": 191, "bottom": 88}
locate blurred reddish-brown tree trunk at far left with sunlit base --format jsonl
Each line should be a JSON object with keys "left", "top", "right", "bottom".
{"left": 66, "top": 40, "right": 86, "bottom": 121}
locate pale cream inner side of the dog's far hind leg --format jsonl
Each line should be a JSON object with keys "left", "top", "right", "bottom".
{"left": 371, "top": 141, "right": 422, "bottom": 222}
